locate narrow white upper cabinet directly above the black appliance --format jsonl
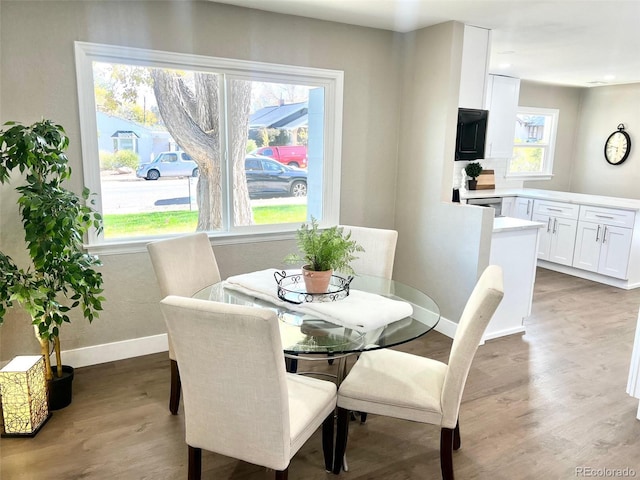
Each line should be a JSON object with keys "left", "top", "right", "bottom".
{"left": 458, "top": 25, "right": 491, "bottom": 109}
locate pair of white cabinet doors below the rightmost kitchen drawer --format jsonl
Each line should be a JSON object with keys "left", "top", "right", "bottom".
{"left": 573, "top": 221, "right": 633, "bottom": 279}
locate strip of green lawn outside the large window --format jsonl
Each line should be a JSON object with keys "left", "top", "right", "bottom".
{"left": 104, "top": 205, "right": 307, "bottom": 238}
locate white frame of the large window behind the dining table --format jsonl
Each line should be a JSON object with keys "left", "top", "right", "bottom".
{"left": 75, "top": 42, "right": 344, "bottom": 253}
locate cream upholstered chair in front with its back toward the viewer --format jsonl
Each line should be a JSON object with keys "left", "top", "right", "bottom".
{"left": 161, "top": 296, "right": 336, "bottom": 480}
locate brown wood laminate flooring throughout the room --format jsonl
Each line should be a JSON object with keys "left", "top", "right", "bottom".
{"left": 0, "top": 269, "right": 640, "bottom": 480}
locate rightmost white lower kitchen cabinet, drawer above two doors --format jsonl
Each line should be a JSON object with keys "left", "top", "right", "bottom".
{"left": 573, "top": 206, "right": 635, "bottom": 279}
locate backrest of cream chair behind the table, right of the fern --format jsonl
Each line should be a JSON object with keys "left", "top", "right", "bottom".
{"left": 340, "top": 225, "right": 398, "bottom": 279}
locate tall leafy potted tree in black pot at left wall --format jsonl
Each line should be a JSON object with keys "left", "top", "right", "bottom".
{"left": 0, "top": 120, "right": 104, "bottom": 410}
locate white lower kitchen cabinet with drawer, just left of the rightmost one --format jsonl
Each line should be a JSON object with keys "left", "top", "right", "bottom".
{"left": 532, "top": 200, "right": 579, "bottom": 265}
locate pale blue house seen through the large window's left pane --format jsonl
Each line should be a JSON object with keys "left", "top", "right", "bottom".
{"left": 96, "top": 112, "right": 177, "bottom": 163}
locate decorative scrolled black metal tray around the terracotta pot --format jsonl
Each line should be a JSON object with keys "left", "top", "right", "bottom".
{"left": 273, "top": 270, "right": 353, "bottom": 304}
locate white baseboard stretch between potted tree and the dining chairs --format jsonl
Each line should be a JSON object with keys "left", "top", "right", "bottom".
{"left": 54, "top": 333, "right": 169, "bottom": 368}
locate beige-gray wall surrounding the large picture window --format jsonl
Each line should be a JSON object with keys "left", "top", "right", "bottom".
{"left": 0, "top": 0, "right": 401, "bottom": 360}
